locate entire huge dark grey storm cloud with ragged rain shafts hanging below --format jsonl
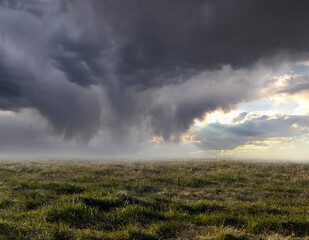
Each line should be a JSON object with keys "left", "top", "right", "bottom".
{"left": 0, "top": 0, "right": 309, "bottom": 146}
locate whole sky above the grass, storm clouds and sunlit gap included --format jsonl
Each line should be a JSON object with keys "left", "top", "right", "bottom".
{"left": 0, "top": 0, "right": 309, "bottom": 161}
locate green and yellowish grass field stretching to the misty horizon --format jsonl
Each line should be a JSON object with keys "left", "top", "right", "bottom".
{"left": 0, "top": 161, "right": 309, "bottom": 240}
